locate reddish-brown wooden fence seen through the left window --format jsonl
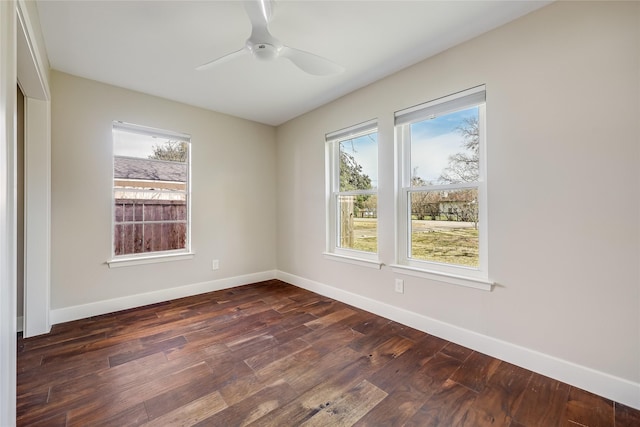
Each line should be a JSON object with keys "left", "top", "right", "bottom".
{"left": 113, "top": 199, "right": 187, "bottom": 255}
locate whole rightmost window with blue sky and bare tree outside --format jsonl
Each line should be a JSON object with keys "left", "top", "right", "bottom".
{"left": 395, "top": 86, "right": 489, "bottom": 288}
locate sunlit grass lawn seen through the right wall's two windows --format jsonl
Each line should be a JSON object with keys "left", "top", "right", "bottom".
{"left": 344, "top": 218, "right": 478, "bottom": 267}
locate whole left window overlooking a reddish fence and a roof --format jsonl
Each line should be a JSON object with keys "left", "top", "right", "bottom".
{"left": 112, "top": 122, "right": 190, "bottom": 266}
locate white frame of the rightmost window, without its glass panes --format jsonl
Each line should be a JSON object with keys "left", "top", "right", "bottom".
{"left": 391, "top": 85, "right": 493, "bottom": 290}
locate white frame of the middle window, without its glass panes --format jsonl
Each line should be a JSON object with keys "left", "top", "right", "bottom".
{"left": 324, "top": 120, "right": 382, "bottom": 269}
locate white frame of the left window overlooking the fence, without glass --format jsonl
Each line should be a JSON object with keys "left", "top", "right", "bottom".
{"left": 107, "top": 121, "right": 194, "bottom": 268}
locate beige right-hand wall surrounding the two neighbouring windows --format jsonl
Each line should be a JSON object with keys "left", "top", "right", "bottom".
{"left": 277, "top": 2, "right": 640, "bottom": 383}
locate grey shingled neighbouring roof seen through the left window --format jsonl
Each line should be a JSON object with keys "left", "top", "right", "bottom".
{"left": 113, "top": 156, "right": 187, "bottom": 182}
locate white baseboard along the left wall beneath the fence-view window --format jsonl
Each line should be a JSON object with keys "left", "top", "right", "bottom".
{"left": 50, "top": 270, "right": 276, "bottom": 325}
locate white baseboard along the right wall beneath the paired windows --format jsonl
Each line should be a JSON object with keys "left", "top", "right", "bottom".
{"left": 276, "top": 271, "right": 640, "bottom": 409}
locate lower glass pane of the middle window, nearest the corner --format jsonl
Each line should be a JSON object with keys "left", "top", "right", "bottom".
{"left": 337, "top": 195, "right": 378, "bottom": 252}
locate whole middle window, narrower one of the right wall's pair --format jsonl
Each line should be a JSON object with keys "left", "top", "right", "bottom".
{"left": 326, "top": 120, "right": 380, "bottom": 268}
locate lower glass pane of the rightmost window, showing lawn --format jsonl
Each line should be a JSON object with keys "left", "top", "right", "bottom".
{"left": 409, "top": 188, "right": 479, "bottom": 267}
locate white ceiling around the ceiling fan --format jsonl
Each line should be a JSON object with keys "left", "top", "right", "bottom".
{"left": 38, "top": 0, "right": 549, "bottom": 125}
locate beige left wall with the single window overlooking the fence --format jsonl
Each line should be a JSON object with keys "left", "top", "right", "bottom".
{"left": 51, "top": 71, "right": 276, "bottom": 310}
